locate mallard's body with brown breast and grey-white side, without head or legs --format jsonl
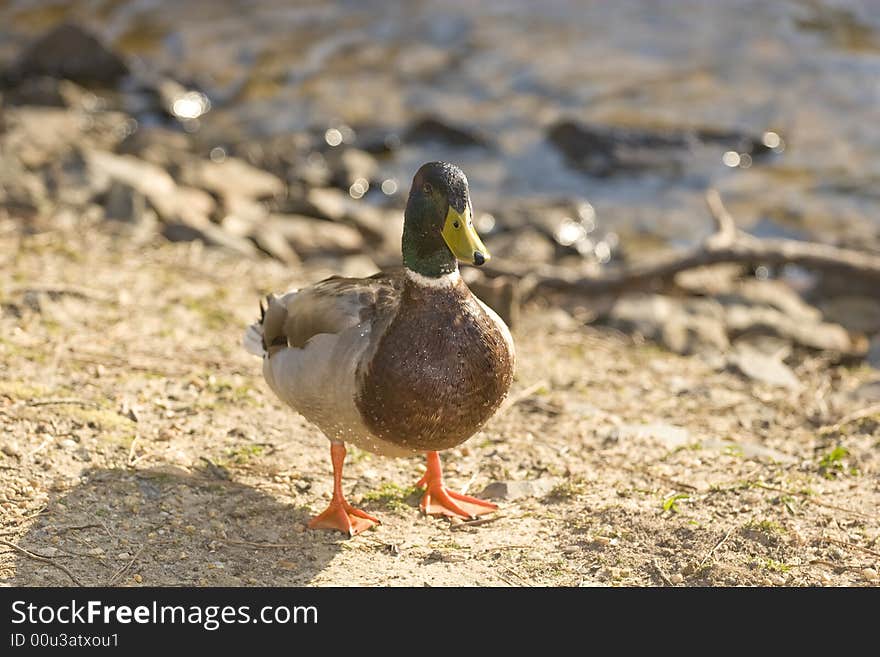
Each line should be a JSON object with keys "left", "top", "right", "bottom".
{"left": 249, "top": 267, "right": 514, "bottom": 456}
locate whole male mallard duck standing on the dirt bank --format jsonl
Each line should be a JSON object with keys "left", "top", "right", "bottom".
{"left": 245, "top": 162, "right": 514, "bottom": 536}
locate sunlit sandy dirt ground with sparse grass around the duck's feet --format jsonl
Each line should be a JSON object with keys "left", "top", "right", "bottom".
{"left": 0, "top": 213, "right": 880, "bottom": 586}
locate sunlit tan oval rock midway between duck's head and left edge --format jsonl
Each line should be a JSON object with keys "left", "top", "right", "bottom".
{"left": 181, "top": 157, "right": 285, "bottom": 199}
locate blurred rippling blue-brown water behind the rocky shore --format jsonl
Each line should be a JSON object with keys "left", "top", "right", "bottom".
{"left": 0, "top": 0, "right": 880, "bottom": 242}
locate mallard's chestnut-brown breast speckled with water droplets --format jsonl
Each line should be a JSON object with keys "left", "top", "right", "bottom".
{"left": 357, "top": 280, "right": 513, "bottom": 451}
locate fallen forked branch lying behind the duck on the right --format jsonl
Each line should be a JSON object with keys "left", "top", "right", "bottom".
{"left": 482, "top": 188, "right": 880, "bottom": 296}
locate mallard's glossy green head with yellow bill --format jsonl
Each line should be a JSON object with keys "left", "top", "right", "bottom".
{"left": 403, "top": 162, "right": 489, "bottom": 277}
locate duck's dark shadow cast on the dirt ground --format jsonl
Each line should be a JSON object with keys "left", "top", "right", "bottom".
{"left": 8, "top": 466, "right": 340, "bottom": 586}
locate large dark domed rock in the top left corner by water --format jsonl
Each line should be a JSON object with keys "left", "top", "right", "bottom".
{"left": 13, "top": 23, "right": 128, "bottom": 87}
